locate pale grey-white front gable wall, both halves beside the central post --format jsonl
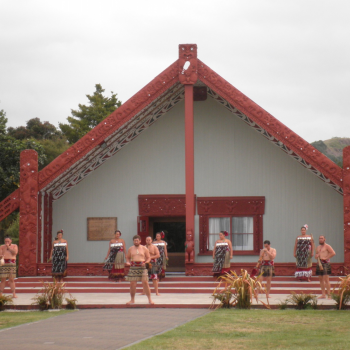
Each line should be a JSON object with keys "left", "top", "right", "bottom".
{"left": 53, "top": 97, "right": 343, "bottom": 262}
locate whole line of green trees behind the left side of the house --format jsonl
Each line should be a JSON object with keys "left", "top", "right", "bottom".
{"left": 0, "top": 84, "right": 121, "bottom": 239}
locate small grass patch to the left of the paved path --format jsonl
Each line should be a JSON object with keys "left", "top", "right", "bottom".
{"left": 0, "top": 310, "right": 72, "bottom": 330}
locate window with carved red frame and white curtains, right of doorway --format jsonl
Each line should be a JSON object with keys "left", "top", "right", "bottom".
{"left": 197, "top": 197, "right": 265, "bottom": 255}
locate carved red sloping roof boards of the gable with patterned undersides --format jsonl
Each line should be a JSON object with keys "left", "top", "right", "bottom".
{"left": 0, "top": 45, "right": 342, "bottom": 221}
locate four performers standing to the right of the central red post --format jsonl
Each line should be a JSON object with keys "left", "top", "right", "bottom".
{"left": 212, "top": 225, "right": 335, "bottom": 299}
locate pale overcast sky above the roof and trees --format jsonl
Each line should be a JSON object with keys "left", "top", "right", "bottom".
{"left": 0, "top": 0, "right": 350, "bottom": 142}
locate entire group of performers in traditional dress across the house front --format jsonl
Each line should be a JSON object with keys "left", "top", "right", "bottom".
{"left": 0, "top": 225, "right": 335, "bottom": 304}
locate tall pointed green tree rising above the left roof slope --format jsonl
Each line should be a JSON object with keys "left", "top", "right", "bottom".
{"left": 59, "top": 84, "right": 121, "bottom": 144}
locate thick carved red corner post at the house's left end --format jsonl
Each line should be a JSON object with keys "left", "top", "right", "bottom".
{"left": 18, "top": 150, "right": 38, "bottom": 276}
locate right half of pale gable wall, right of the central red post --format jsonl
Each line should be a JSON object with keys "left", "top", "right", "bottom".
{"left": 195, "top": 98, "right": 344, "bottom": 262}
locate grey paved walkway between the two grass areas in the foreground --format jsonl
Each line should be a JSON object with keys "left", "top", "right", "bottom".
{"left": 0, "top": 309, "right": 210, "bottom": 350}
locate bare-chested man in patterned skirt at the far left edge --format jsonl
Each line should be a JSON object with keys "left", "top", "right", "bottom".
{"left": 0, "top": 235, "right": 18, "bottom": 298}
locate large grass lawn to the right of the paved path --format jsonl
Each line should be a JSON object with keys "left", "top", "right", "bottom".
{"left": 128, "top": 309, "right": 350, "bottom": 350}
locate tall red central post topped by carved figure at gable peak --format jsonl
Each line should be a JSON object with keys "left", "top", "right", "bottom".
{"left": 178, "top": 44, "right": 198, "bottom": 264}
